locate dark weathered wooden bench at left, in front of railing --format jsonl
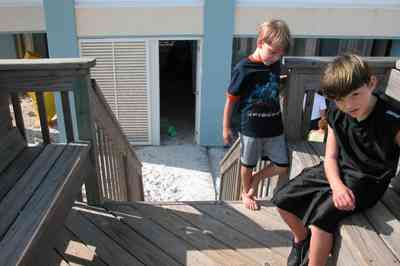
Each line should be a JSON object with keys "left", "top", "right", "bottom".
{"left": 0, "top": 65, "right": 92, "bottom": 265}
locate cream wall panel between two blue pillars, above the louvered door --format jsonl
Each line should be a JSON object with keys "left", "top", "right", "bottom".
{"left": 76, "top": 7, "right": 203, "bottom": 37}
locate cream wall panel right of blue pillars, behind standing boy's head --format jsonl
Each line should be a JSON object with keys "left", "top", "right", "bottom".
{"left": 235, "top": 6, "right": 400, "bottom": 38}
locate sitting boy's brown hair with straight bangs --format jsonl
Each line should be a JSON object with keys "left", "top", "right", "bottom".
{"left": 321, "top": 54, "right": 371, "bottom": 100}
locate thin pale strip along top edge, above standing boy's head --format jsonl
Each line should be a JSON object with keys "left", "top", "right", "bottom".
{"left": 236, "top": 0, "right": 400, "bottom": 9}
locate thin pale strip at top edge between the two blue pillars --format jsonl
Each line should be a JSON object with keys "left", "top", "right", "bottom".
{"left": 75, "top": 0, "right": 204, "bottom": 7}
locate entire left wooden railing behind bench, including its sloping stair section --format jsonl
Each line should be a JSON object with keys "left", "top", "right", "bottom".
{"left": 0, "top": 58, "right": 144, "bottom": 204}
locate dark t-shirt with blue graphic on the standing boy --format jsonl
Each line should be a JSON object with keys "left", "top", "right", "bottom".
{"left": 228, "top": 58, "right": 283, "bottom": 138}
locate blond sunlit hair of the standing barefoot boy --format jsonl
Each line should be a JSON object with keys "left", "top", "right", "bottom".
{"left": 257, "top": 19, "right": 292, "bottom": 53}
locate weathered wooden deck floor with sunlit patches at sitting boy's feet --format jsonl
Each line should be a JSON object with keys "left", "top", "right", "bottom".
{"left": 45, "top": 201, "right": 290, "bottom": 266}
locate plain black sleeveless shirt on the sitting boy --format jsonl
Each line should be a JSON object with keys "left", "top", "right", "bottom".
{"left": 328, "top": 94, "right": 400, "bottom": 180}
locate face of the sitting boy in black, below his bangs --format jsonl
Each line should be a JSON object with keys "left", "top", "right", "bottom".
{"left": 335, "top": 78, "right": 376, "bottom": 119}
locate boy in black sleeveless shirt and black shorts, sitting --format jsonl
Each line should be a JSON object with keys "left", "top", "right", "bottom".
{"left": 273, "top": 55, "right": 400, "bottom": 266}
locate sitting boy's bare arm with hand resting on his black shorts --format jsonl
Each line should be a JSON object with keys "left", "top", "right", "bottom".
{"left": 324, "top": 126, "right": 355, "bottom": 210}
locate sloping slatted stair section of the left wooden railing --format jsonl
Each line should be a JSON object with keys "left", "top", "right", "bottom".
{"left": 89, "top": 80, "right": 144, "bottom": 201}
